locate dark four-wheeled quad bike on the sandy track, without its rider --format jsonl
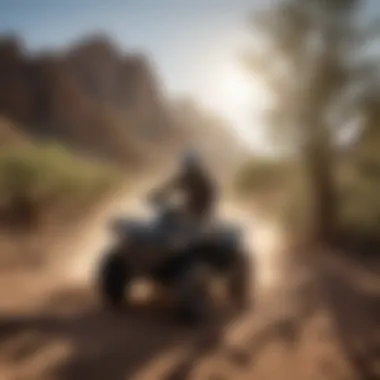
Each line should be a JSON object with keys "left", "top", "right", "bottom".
{"left": 97, "top": 194, "right": 253, "bottom": 324}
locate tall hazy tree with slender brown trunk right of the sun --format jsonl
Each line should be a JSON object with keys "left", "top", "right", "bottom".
{"left": 245, "top": 0, "right": 377, "bottom": 241}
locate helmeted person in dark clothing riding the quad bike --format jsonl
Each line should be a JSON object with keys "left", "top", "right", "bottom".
{"left": 151, "top": 150, "right": 216, "bottom": 232}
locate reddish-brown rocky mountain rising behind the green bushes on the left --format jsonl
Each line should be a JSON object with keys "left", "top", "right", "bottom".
{"left": 0, "top": 35, "right": 243, "bottom": 169}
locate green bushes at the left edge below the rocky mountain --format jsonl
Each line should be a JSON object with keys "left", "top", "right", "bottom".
{"left": 0, "top": 144, "right": 119, "bottom": 220}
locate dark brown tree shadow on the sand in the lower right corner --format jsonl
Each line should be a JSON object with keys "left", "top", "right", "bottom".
{"left": 320, "top": 252, "right": 380, "bottom": 380}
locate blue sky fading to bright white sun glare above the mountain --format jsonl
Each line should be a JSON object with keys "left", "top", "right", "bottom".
{"left": 0, "top": 0, "right": 380, "bottom": 151}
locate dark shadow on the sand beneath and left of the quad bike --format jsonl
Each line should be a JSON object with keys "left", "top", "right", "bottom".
{"left": 0, "top": 290, "right": 246, "bottom": 380}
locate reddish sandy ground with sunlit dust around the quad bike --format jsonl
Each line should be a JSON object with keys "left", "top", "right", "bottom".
{"left": 0, "top": 179, "right": 380, "bottom": 380}
